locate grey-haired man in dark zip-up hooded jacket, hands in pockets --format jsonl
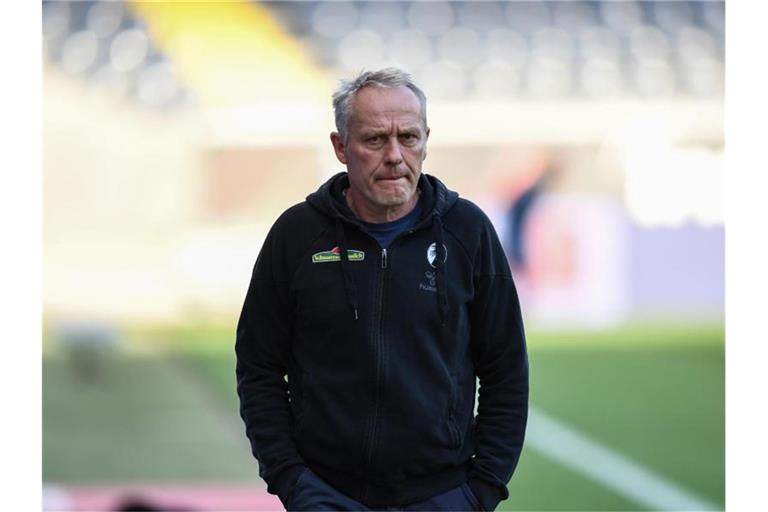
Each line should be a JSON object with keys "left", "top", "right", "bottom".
{"left": 236, "top": 68, "right": 528, "bottom": 510}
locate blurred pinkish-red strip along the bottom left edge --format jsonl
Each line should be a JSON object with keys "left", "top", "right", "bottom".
{"left": 43, "top": 482, "right": 284, "bottom": 511}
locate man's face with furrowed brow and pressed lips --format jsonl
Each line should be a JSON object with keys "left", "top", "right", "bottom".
{"left": 331, "top": 86, "right": 429, "bottom": 220}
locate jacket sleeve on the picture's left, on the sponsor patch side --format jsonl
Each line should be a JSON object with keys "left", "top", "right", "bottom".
{"left": 235, "top": 228, "right": 304, "bottom": 506}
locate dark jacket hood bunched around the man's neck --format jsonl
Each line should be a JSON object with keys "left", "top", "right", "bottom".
{"left": 307, "top": 172, "right": 459, "bottom": 223}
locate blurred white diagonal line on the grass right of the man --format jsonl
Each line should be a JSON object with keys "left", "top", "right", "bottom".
{"left": 525, "top": 408, "right": 723, "bottom": 510}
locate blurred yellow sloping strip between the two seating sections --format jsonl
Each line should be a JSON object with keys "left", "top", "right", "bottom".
{"left": 130, "top": 1, "right": 331, "bottom": 109}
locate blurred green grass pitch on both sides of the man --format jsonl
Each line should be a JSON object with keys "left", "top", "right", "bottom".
{"left": 43, "top": 324, "right": 725, "bottom": 510}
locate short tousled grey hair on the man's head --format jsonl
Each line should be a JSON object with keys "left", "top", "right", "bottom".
{"left": 333, "top": 68, "right": 427, "bottom": 143}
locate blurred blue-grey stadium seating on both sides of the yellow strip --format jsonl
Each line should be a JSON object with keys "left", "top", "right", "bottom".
{"left": 43, "top": 1, "right": 725, "bottom": 108}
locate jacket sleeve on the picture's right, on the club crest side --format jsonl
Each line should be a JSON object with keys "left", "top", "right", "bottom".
{"left": 469, "top": 220, "right": 528, "bottom": 511}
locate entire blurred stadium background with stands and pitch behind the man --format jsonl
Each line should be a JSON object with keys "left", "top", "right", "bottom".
{"left": 42, "top": 1, "right": 725, "bottom": 510}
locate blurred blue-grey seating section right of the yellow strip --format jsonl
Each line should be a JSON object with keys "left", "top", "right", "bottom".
{"left": 262, "top": 1, "right": 724, "bottom": 99}
